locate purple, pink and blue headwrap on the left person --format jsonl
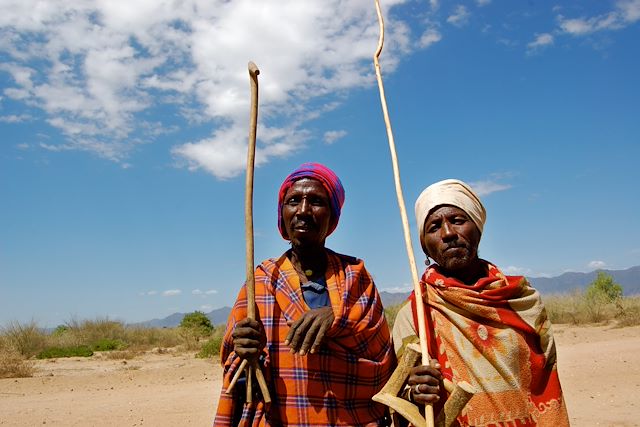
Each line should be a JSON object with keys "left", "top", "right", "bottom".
{"left": 278, "top": 162, "right": 344, "bottom": 240}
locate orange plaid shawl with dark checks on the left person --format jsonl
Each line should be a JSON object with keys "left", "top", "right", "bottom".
{"left": 215, "top": 249, "right": 395, "bottom": 426}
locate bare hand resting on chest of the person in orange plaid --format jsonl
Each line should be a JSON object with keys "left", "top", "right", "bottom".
{"left": 284, "top": 307, "right": 334, "bottom": 356}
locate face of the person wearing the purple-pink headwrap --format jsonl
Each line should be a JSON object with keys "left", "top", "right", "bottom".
{"left": 282, "top": 178, "right": 331, "bottom": 246}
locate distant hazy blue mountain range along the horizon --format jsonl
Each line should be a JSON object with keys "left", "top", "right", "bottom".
{"left": 137, "top": 266, "right": 640, "bottom": 328}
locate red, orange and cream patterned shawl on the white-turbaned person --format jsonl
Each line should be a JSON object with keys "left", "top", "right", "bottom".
{"left": 410, "top": 263, "right": 569, "bottom": 427}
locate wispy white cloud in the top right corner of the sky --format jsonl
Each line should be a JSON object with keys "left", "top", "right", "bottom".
{"left": 558, "top": 0, "right": 640, "bottom": 36}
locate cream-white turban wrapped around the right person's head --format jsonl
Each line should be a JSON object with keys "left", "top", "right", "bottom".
{"left": 415, "top": 179, "right": 487, "bottom": 242}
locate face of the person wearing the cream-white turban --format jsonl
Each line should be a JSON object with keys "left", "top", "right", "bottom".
{"left": 422, "top": 205, "right": 481, "bottom": 273}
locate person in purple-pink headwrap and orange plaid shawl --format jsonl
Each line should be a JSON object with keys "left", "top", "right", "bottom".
{"left": 215, "top": 163, "right": 395, "bottom": 426}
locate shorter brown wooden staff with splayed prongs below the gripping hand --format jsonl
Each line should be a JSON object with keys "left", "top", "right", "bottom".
{"left": 226, "top": 61, "right": 271, "bottom": 403}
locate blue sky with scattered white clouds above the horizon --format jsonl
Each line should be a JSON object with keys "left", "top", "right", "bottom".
{"left": 0, "top": 0, "right": 640, "bottom": 326}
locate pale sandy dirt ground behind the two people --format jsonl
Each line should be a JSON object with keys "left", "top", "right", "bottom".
{"left": 0, "top": 325, "right": 640, "bottom": 427}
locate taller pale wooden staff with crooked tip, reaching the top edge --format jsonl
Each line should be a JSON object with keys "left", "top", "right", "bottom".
{"left": 373, "top": 0, "right": 434, "bottom": 427}
